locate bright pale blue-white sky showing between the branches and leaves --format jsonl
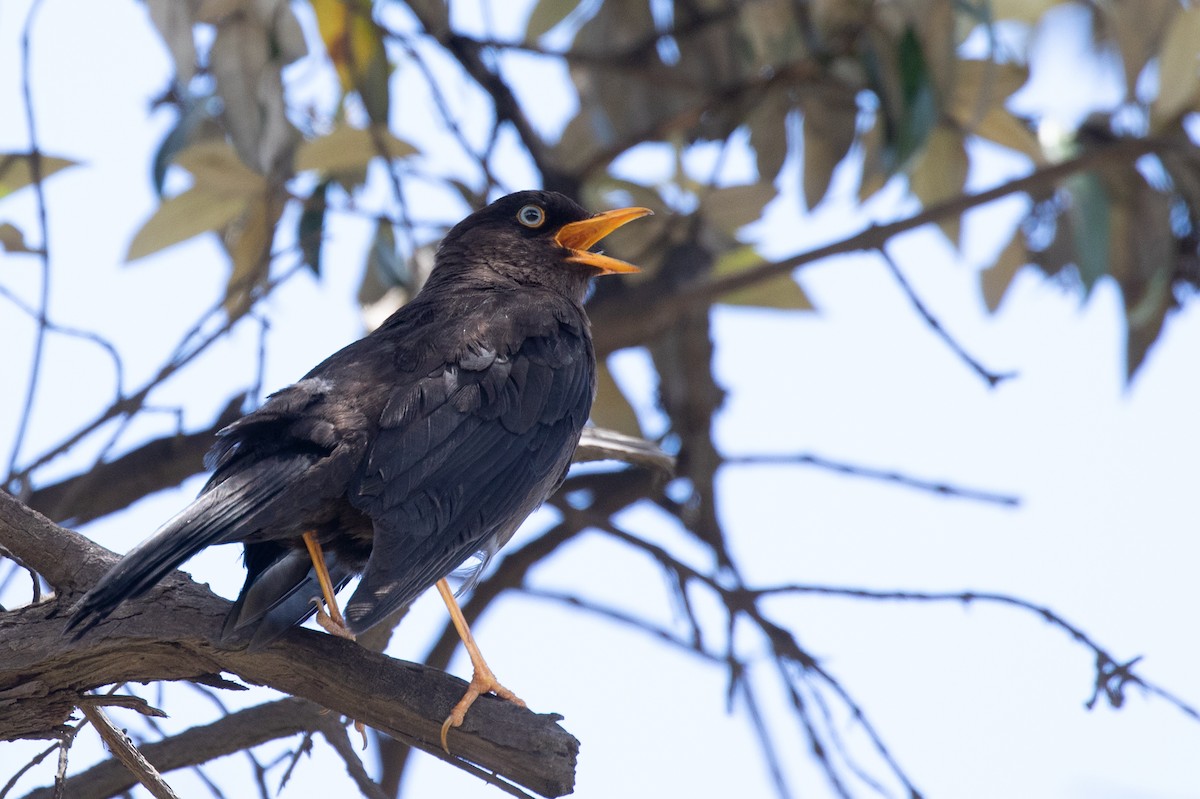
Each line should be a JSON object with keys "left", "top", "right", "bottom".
{"left": 0, "top": 0, "right": 1200, "bottom": 798}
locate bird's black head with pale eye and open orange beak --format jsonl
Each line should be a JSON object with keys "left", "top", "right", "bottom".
{"left": 436, "top": 191, "right": 653, "bottom": 300}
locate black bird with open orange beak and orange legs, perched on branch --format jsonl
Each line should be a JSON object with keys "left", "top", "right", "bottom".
{"left": 66, "top": 191, "right": 652, "bottom": 752}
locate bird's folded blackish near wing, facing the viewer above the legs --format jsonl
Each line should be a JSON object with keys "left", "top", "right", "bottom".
{"left": 344, "top": 308, "right": 594, "bottom": 632}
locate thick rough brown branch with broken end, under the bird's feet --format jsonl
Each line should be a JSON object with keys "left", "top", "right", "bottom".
{"left": 0, "top": 492, "right": 578, "bottom": 797}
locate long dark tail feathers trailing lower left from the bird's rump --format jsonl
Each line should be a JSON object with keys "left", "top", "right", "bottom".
{"left": 67, "top": 380, "right": 366, "bottom": 637}
